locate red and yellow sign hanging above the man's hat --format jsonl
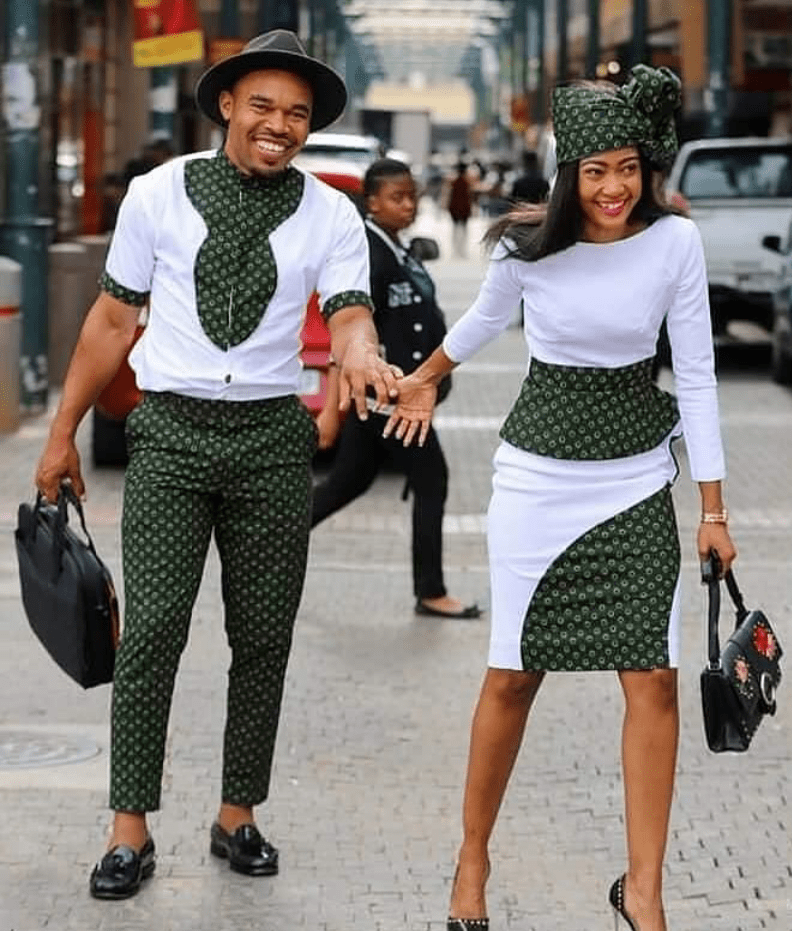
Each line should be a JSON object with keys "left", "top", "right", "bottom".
{"left": 132, "top": 0, "right": 204, "bottom": 68}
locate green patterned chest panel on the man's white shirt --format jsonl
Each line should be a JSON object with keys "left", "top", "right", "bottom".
{"left": 184, "top": 151, "right": 305, "bottom": 349}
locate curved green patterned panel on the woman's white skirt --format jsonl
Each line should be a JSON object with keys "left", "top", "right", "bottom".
{"left": 521, "top": 486, "right": 680, "bottom": 671}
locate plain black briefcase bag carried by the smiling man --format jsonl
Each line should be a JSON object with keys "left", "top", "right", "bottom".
{"left": 15, "top": 485, "right": 119, "bottom": 689}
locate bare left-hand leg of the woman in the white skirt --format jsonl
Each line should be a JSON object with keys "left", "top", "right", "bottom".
{"left": 449, "top": 669, "right": 544, "bottom": 918}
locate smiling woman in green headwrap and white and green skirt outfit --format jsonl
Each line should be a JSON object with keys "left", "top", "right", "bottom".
{"left": 386, "top": 65, "right": 736, "bottom": 931}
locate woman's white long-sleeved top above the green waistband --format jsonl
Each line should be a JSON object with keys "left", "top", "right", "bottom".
{"left": 443, "top": 216, "right": 725, "bottom": 481}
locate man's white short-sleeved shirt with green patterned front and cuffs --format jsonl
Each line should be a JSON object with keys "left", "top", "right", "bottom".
{"left": 101, "top": 151, "right": 371, "bottom": 401}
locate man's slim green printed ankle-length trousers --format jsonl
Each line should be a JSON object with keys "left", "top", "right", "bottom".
{"left": 110, "top": 393, "right": 316, "bottom": 811}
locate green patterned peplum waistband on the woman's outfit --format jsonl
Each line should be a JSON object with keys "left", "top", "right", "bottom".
{"left": 500, "top": 359, "right": 679, "bottom": 460}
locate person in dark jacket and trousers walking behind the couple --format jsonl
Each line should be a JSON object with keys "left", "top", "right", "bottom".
{"left": 311, "top": 158, "right": 481, "bottom": 619}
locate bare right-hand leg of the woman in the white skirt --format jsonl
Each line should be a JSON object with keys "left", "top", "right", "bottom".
{"left": 619, "top": 669, "right": 679, "bottom": 931}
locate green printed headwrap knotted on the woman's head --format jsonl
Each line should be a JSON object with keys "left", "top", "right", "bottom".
{"left": 553, "top": 65, "right": 682, "bottom": 168}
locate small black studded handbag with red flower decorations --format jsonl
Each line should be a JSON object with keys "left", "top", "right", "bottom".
{"left": 701, "top": 553, "right": 784, "bottom": 753}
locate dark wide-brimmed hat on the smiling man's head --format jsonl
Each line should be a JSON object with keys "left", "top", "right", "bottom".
{"left": 195, "top": 29, "right": 347, "bottom": 130}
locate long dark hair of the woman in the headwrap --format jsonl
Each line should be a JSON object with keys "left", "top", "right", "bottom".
{"left": 484, "top": 150, "right": 676, "bottom": 262}
